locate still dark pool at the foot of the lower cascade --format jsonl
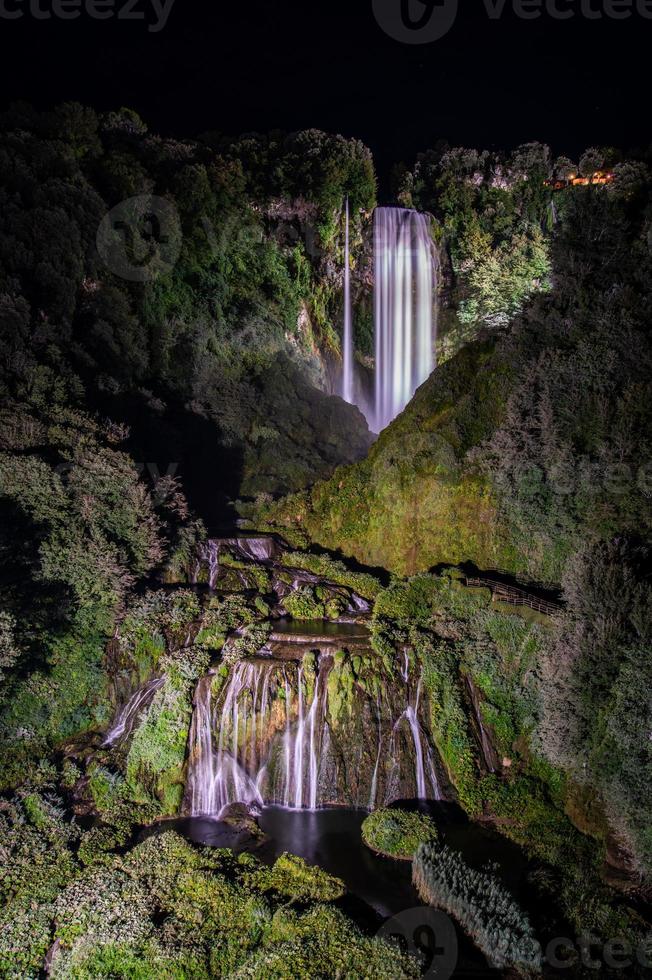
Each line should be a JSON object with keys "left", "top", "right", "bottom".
{"left": 168, "top": 802, "right": 525, "bottom": 980}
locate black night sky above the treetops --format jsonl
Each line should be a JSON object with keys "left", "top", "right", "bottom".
{"left": 0, "top": 0, "right": 652, "bottom": 179}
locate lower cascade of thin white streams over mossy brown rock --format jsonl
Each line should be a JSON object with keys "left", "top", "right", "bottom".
{"left": 184, "top": 651, "right": 441, "bottom": 816}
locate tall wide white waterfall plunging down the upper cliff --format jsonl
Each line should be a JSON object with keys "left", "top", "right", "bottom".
{"left": 374, "top": 208, "right": 436, "bottom": 432}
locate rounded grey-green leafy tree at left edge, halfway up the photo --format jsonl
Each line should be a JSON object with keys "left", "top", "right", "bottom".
{"left": 0, "top": 410, "right": 161, "bottom": 612}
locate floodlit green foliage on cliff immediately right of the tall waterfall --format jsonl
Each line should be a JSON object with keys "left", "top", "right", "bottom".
{"left": 401, "top": 143, "right": 552, "bottom": 363}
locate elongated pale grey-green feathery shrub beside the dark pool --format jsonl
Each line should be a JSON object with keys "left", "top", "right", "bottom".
{"left": 412, "top": 844, "right": 542, "bottom": 976}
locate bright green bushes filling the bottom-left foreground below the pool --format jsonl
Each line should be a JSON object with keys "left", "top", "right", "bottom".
{"left": 0, "top": 815, "right": 417, "bottom": 980}
